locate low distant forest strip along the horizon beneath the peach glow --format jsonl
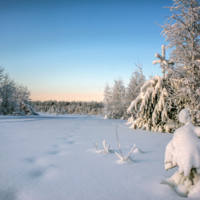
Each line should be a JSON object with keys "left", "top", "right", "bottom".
{"left": 31, "top": 100, "right": 104, "bottom": 115}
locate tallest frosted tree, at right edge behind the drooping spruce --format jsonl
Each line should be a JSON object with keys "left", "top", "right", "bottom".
{"left": 161, "top": 0, "right": 200, "bottom": 126}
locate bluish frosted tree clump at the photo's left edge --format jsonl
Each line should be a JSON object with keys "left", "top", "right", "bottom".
{"left": 0, "top": 67, "right": 37, "bottom": 115}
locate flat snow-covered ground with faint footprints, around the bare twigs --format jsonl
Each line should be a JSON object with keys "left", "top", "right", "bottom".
{"left": 0, "top": 114, "right": 190, "bottom": 200}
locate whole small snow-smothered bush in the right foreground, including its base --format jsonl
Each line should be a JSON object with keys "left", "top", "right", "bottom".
{"left": 164, "top": 109, "right": 200, "bottom": 196}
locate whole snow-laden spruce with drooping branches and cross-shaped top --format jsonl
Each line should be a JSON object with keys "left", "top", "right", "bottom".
{"left": 127, "top": 45, "right": 176, "bottom": 132}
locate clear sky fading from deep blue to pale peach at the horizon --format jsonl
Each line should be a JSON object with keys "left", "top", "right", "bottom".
{"left": 0, "top": 0, "right": 173, "bottom": 101}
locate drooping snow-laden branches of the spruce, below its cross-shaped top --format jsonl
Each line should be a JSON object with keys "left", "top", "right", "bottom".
{"left": 127, "top": 72, "right": 170, "bottom": 132}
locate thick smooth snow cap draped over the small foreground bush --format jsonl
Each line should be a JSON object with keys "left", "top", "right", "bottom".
{"left": 165, "top": 109, "right": 200, "bottom": 176}
